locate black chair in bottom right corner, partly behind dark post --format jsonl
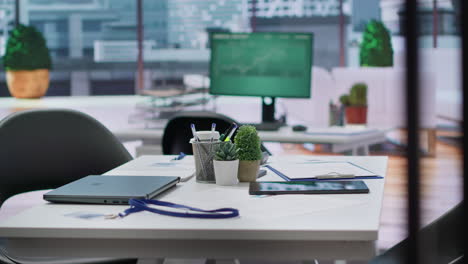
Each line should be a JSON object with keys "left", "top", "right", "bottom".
{"left": 369, "top": 202, "right": 465, "bottom": 264}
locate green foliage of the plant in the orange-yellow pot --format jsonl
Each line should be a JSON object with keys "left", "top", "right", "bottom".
{"left": 3, "top": 24, "right": 52, "bottom": 71}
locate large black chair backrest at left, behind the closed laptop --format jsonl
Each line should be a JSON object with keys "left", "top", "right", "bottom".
{"left": 0, "top": 109, "right": 132, "bottom": 205}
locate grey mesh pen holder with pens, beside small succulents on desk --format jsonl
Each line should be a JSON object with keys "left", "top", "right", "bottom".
{"left": 190, "top": 139, "right": 221, "bottom": 183}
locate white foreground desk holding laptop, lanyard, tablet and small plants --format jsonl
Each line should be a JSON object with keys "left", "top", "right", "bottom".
{"left": 0, "top": 156, "right": 387, "bottom": 260}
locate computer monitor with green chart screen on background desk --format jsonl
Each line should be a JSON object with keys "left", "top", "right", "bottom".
{"left": 210, "top": 32, "right": 313, "bottom": 130}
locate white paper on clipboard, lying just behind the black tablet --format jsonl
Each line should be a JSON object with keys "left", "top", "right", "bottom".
{"left": 266, "top": 162, "right": 376, "bottom": 180}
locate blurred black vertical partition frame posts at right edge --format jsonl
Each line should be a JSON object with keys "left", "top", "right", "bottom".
{"left": 404, "top": 0, "right": 468, "bottom": 264}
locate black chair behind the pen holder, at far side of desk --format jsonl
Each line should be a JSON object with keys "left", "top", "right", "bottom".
{"left": 162, "top": 111, "right": 271, "bottom": 155}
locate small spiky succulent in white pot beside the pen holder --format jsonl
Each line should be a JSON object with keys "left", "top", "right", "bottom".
{"left": 213, "top": 141, "right": 239, "bottom": 185}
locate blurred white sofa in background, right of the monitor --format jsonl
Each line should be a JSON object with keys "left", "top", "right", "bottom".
{"left": 279, "top": 64, "right": 436, "bottom": 128}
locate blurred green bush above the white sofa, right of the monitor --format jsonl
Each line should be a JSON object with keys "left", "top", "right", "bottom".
{"left": 359, "top": 20, "right": 393, "bottom": 67}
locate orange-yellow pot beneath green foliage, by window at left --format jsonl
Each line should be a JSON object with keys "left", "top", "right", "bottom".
{"left": 6, "top": 69, "right": 49, "bottom": 98}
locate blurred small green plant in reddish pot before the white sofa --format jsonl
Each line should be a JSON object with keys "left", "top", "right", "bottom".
{"left": 340, "top": 83, "right": 367, "bottom": 124}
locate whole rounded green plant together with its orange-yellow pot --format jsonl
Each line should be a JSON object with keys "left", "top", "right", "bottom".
{"left": 3, "top": 24, "right": 52, "bottom": 98}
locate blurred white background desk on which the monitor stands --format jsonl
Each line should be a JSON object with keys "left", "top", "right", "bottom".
{"left": 112, "top": 127, "right": 390, "bottom": 155}
